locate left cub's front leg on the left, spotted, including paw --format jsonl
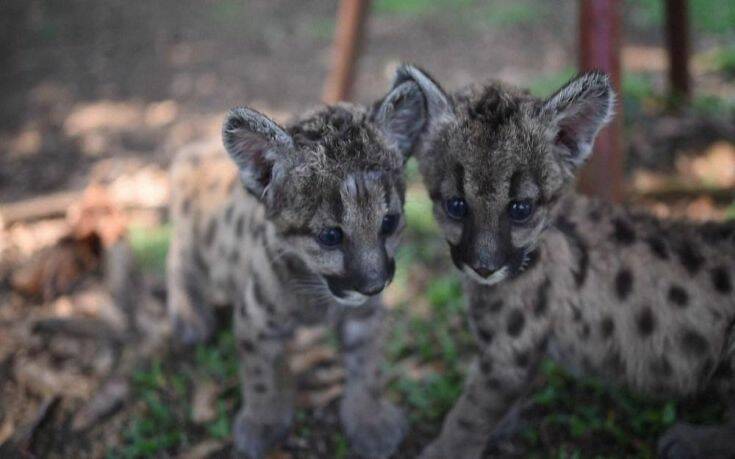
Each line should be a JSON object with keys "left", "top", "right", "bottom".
{"left": 233, "top": 290, "right": 294, "bottom": 459}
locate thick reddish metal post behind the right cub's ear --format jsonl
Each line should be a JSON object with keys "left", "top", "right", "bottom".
{"left": 579, "top": 0, "right": 624, "bottom": 202}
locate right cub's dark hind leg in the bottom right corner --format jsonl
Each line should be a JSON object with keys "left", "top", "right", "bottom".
{"left": 658, "top": 357, "right": 735, "bottom": 459}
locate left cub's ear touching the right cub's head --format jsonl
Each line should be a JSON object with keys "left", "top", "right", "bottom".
{"left": 373, "top": 81, "right": 427, "bottom": 158}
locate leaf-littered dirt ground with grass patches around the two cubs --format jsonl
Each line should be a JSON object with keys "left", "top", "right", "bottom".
{"left": 0, "top": 0, "right": 735, "bottom": 458}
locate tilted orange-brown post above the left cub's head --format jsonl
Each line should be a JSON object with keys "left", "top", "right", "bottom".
{"left": 322, "top": 0, "right": 370, "bottom": 104}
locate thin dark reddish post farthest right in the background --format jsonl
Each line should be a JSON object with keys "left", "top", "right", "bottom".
{"left": 666, "top": 0, "right": 691, "bottom": 104}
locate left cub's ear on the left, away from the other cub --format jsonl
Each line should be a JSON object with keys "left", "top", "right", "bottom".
{"left": 222, "top": 107, "right": 293, "bottom": 198}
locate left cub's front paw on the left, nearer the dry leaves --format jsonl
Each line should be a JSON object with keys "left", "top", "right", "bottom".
{"left": 232, "top": 410, "right": 291, "bottom": 459}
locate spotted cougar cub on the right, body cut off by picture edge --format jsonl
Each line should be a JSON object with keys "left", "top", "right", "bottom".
{"left": 396, "top": 66, "right": 735, "bottom": 458}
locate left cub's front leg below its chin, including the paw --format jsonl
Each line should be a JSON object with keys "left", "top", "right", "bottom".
{"left": 339, "top": 300, "right": 408, "bottom": 458}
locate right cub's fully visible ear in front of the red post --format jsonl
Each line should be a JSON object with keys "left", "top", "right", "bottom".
{"left": 541, "top": 72, "right": 615, "bottom": 168}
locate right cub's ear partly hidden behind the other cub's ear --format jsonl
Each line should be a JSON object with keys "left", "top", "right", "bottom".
{"left": 393, "top": 64, "right": 454, "bottom": 146}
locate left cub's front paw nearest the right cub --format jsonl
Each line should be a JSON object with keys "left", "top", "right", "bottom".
{"left": 339, "top": 395, "right": 408, "bottom": 458}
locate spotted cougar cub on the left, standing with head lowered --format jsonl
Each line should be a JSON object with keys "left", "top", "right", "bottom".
{"left": 168, "top": 82, "right": 424, "bottom": 458}
